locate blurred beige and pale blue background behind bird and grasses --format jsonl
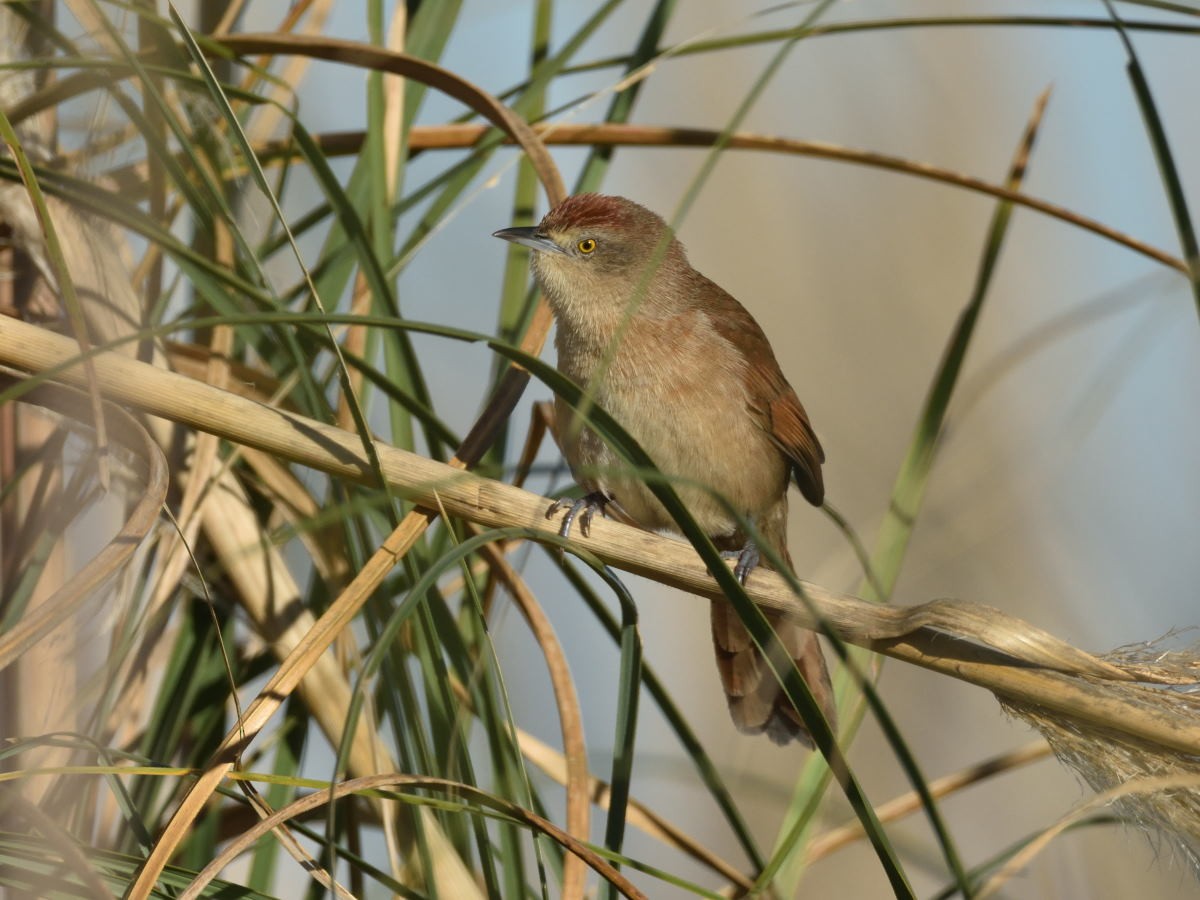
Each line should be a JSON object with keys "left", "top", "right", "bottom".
{"left": 4, "top": 0, "right": 1200, "bottom": 900}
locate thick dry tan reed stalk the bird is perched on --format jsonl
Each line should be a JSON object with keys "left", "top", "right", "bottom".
{"left": 0, "top": 320, "right": 1200, "bottom": 878}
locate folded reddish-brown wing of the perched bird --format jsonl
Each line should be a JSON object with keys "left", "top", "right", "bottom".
{"left": 706, "top": 282, "right": 824, "bottom": 506}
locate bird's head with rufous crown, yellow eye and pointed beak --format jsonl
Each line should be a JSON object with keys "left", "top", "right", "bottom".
{"left": 493, "top": 193, "right": 690, "bottom": 314}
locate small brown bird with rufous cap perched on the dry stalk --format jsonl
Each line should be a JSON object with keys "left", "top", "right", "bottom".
{"left": 494, "top": 194, "right": 834, "bottom": 744}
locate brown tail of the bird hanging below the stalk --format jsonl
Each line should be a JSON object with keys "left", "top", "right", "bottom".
{"left": 712, "top": 600, "right": 836, "bottom": 746}
